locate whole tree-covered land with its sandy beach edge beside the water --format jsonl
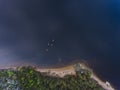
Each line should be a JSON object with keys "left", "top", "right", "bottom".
{"left": 0, "top": 63, "right": 115, "bottom": 90}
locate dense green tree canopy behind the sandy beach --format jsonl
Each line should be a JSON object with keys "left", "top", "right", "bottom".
{"left": 0, "top": 66, "right": 104, "bottom": 90}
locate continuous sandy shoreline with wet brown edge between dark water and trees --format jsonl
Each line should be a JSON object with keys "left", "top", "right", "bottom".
{"left": 0, "top": 61, "right": 115, "bottom": 90}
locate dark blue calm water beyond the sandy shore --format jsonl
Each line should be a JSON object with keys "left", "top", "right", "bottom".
{"left": 0, "top": 0, "right": 120, "bottom": 90}
